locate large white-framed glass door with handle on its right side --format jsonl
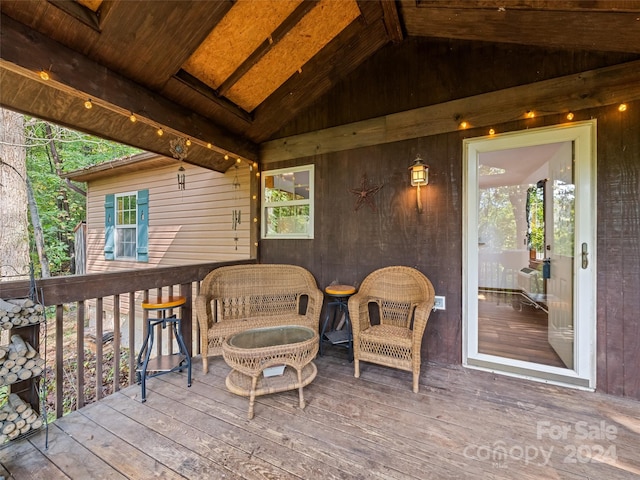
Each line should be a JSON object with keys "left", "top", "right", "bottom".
{"left": 463, "top": 120, "right": 596, "bottom": 389}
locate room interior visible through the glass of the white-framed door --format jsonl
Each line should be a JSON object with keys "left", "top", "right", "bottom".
{"left": 478, "top": 141, "right": 574, "bottom": 368}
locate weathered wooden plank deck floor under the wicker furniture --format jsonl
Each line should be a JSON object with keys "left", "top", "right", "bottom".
{"left": 0, "top": 350, "right": 640, "bottom": 480}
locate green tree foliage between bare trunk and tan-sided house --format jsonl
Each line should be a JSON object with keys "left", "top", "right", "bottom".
{"left": 25, "top": 117, "right": 140, "bottom": 276}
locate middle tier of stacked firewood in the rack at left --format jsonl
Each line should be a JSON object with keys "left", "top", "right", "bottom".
{"left": 0, "top": 335, "right": 45, "bottom": 385}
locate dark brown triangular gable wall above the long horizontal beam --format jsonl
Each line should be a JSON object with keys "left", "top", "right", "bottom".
{"left": 273, "top": 37, "right": 640, "bottom": 138}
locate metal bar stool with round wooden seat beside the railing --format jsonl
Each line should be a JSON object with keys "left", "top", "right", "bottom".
{"left": 136, "top": 296, "right": 191, "bottom": 402}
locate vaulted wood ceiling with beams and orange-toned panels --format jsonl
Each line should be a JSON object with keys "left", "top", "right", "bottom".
{"left": 0, "top": 0, "right": 640, "bottom": 171}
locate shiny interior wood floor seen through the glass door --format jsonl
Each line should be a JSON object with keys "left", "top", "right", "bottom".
{"left": 478, "top": 292, "right": 566, "bottom": 368}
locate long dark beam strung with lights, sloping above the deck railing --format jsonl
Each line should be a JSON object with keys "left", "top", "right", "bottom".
{"left": 0, "top": 15, "right": 257, "bottom": 167}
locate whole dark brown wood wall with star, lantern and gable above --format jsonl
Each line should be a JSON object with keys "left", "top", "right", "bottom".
{"left": 260, "top": 39, "right": 640, "bottom": 398}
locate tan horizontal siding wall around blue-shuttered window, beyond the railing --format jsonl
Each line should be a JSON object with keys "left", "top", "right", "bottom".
{"left": 87, "top": 164, "right": 252, "bottom": 273}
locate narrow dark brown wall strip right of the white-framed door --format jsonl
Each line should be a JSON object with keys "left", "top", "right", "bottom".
{"left": 592, "top": 102, "right": 640, "bottom": 399}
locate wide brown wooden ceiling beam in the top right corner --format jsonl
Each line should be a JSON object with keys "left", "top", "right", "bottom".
{"left": 400, "top": 0, "right": 640, "bottom": 53}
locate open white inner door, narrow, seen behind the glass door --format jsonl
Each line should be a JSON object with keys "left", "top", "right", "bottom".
{"left": 545, "top": 142, "right": 576, "bottom": 369}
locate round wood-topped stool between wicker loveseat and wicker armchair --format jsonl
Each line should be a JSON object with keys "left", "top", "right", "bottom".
{"left": 320, "top": 285, "right": 356, "bottom": 361}
